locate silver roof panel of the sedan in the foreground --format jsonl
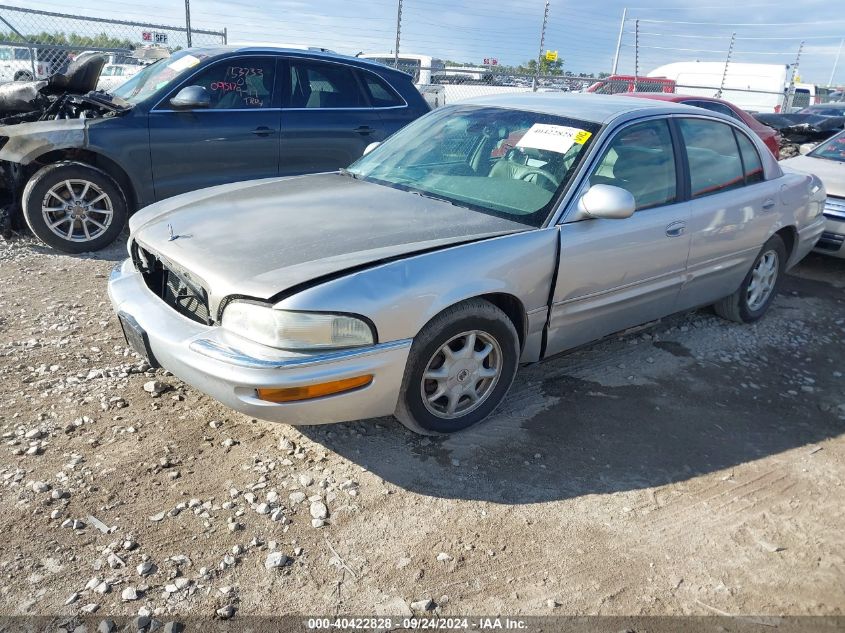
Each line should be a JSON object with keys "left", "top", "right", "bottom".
{"left": 458, "top": 92, "right": 716, "bottom": 124}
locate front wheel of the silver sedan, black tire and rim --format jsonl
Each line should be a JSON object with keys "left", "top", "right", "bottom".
{"left": 394, "top": 299, "right": 520, "bottom": 435}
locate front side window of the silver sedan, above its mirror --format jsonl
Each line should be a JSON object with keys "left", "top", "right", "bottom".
{"left": 590, "top": 119, "right": 677, "bottom": 211}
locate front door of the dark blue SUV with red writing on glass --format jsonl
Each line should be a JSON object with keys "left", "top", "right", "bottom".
{"left": 149, "top": 56, "right": 281, "bottom": 200}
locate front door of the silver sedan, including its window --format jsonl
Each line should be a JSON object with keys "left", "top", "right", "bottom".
{"left": 546, "top": 118, "right": 690, "bottom": 355}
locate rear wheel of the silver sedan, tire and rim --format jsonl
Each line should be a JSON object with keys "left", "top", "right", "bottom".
{"left": 713, "top": 235, "right": 788, "bottom": 323}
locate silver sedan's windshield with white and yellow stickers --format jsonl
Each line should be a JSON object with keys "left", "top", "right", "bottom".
{"left": 347, "top": 106, "right": 599, "bottom": 226}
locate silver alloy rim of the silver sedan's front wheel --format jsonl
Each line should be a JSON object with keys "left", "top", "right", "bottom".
{"left": 420, "top": 330, "right": 502, "bottom": 419}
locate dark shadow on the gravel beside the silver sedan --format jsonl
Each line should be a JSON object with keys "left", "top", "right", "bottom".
{"left": 300, "top": 257, "right": 845, "bottom": 504}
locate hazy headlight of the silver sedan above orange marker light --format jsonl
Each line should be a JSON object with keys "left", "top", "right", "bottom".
{"left": 221, "top": 301, "right": 375, "bottom": 350}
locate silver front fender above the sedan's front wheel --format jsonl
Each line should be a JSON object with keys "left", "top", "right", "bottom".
{"left": 275, "top": 227, "right": 559, "bottom": 362}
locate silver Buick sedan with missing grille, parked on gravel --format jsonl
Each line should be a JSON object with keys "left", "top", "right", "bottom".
{"left": 109, "top": 93, "right": 825, "bottom": 434}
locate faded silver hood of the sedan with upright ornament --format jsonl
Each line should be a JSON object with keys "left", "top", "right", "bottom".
{"left": 129, "top": 173, "right": 531, "bottom": 310}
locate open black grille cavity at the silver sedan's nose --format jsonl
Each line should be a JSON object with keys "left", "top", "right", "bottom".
{"left": 132, "top": 244, "right": 211, "bottom": 325}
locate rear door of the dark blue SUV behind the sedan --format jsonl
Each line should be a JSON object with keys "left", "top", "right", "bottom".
{"left": 280, "top": 58, "right": 387, "bottom": 176}
